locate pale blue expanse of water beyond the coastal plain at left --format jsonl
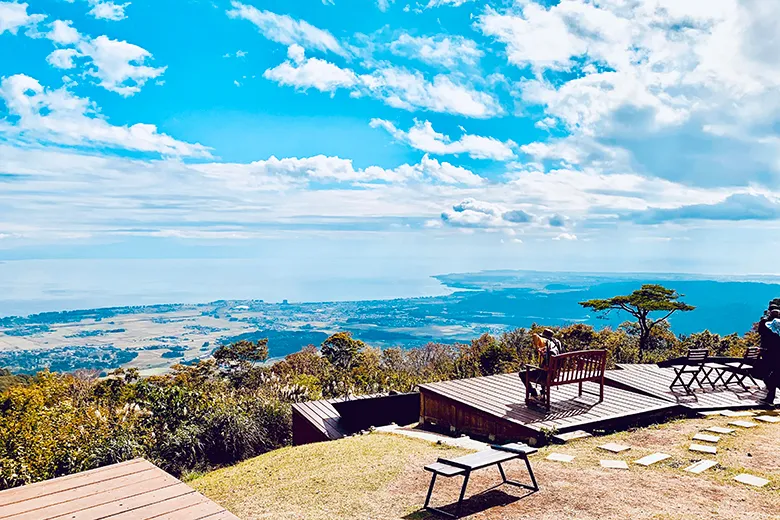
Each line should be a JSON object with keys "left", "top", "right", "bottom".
{"left": 0, "top": 259, "right": 451, "bottom": 316}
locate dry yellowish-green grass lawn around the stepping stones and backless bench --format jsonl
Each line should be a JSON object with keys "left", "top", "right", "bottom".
{"left": 190, "top": 416, "right": 780, "bottom": 520}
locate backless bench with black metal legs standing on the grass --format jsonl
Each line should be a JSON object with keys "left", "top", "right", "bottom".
{"left": 423, "top": 443, "right": 539, "bottom": 518}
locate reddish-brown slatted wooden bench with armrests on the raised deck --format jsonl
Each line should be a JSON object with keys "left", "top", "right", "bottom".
{"left": 520, "top": 350, "right": 607, "bottom": 408}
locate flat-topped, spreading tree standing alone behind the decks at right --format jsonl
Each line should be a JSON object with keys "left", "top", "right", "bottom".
{"left": 580, "top": 284, "right": 696, "bottom": 359}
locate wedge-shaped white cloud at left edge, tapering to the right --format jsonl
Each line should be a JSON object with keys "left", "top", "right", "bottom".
{"left": 0, "top": 74, "right": 210, "bottom": 157}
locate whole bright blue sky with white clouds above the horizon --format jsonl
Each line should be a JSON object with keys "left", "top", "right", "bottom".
{"left": 0, "top": 0, "right": 780, "bottom": 308}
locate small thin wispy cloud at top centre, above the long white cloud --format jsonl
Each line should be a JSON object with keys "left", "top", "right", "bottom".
{"left": 390, "top": 33, "right": 484, "bottom": 69}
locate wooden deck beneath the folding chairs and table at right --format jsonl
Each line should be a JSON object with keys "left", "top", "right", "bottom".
{"left": 605, "top": 365, "right": 780, "bottom": 411}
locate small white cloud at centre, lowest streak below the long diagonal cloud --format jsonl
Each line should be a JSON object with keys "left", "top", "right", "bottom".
{"left": 370, "top": 119, "right": 517, "bottom": 161}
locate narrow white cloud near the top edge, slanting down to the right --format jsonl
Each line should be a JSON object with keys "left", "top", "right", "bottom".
{"left": 227, "top": 1, "right": 346, "bottom": 55}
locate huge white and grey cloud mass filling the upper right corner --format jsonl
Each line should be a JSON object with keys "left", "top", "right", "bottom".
{"left": 475, "top": 0, "right": 780, "bottom": 187}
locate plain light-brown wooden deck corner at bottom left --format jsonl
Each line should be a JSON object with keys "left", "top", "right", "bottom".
{"left": 0, "top": 459, "right": 238, "bottom": 520}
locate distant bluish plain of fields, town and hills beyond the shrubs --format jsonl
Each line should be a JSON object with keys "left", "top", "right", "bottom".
{"left": 0, "top": 271, "right": 780, "bottom": 375}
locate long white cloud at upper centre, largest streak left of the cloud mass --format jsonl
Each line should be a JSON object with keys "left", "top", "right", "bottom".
{"left": 264, "top": 46, "right": 503, "bottom": 118}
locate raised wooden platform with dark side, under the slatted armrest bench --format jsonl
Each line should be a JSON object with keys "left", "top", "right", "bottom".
{"left": 420, "top": 373, "right": 677, "bottom": 440}
